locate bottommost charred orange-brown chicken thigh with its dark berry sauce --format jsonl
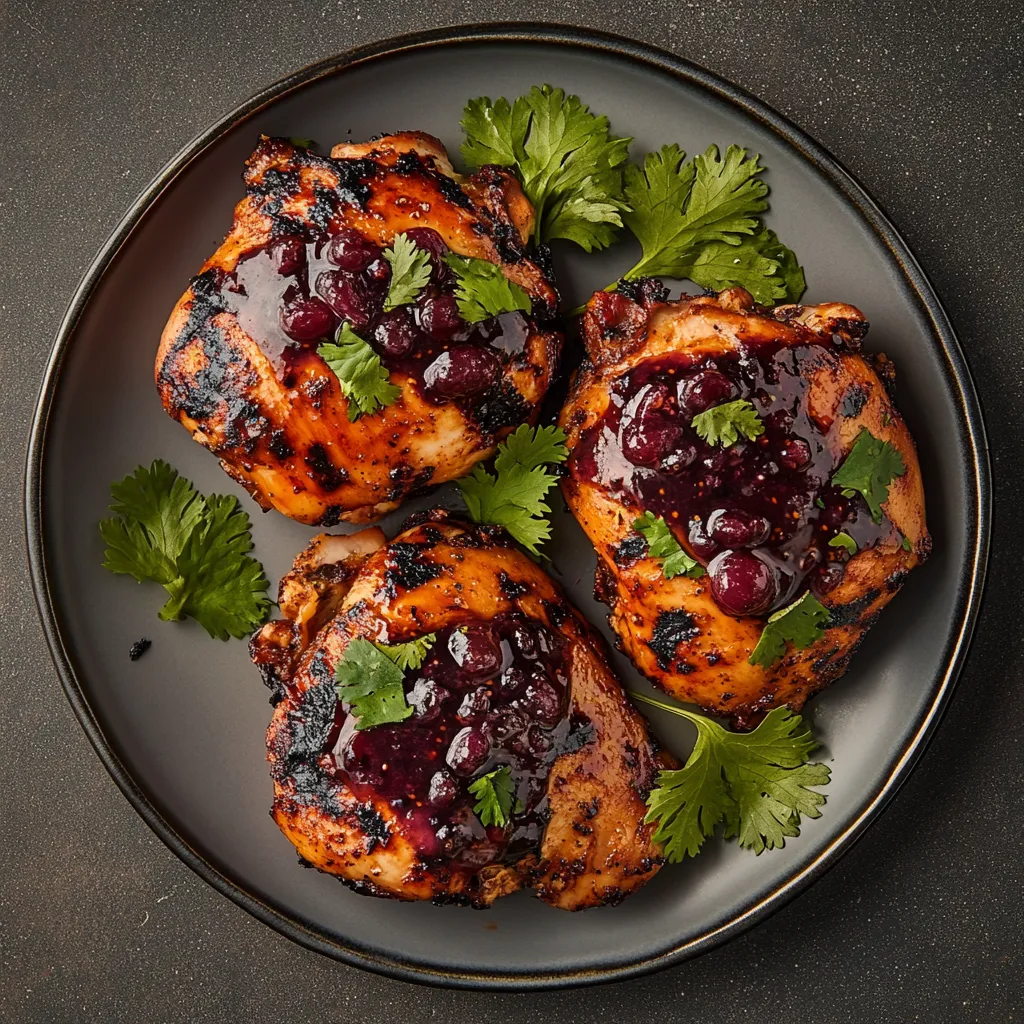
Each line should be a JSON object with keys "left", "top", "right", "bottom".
{"left": 251, "top": 512, "right": 667, "bottom": 910}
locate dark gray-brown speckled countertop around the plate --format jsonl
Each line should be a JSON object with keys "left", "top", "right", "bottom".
{"left": 0, "top": 0, "right": 1024, "bottom": 1024}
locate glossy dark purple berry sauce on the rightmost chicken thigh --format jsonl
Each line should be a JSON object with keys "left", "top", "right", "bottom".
{"left": 570, "top": 345, "right": 893, "bottom": 615}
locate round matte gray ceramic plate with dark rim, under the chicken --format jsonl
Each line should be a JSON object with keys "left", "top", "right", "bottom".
{"left": 27, "top": 26, "right": 988, "bottom": 987}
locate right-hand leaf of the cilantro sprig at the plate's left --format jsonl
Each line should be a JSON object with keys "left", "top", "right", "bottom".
{"left": 160, "top": 495, "right": 270, "bottom": 640}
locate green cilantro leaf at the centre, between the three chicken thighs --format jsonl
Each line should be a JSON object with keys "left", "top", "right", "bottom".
{"left": 456, "top": 424, "right": 568, "bottom": 555}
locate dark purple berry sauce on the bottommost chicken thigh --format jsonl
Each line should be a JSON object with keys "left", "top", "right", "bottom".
{"left": 326, "top": 614, "right": 591, "bottom": 865}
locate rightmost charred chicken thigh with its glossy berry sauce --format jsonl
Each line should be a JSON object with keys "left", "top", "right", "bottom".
{"left": 561, "top": 282, "right": 931, "bottom": 727}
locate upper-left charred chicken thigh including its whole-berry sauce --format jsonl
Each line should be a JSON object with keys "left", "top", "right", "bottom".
{"left": 156, "top": 132, "right": 561, "bottom": 526}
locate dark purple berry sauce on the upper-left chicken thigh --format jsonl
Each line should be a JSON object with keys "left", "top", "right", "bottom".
{"left": 209, "top": 228, "right": 529, "bottom": 403}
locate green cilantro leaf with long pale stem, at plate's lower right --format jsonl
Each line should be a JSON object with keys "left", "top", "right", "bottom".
{"left": 630, "top": 693, "right": 830, "bottom": 861}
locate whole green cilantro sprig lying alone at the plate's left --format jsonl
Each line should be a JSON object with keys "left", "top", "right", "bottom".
{"left": 99, "top": 459, "right": 270, "bottom": 640}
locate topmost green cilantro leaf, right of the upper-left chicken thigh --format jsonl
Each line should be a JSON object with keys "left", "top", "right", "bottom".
{"left": 462, "top": 85, "right": 630, "bottom": 252}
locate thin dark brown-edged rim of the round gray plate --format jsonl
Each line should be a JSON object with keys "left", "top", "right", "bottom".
{"left": 24, "top": 22, "right": 992, "bottom": 991}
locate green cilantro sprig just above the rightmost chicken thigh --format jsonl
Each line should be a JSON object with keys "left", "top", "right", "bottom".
{"left": 623, "top": 144, "right": 805, "bottom": 305}
